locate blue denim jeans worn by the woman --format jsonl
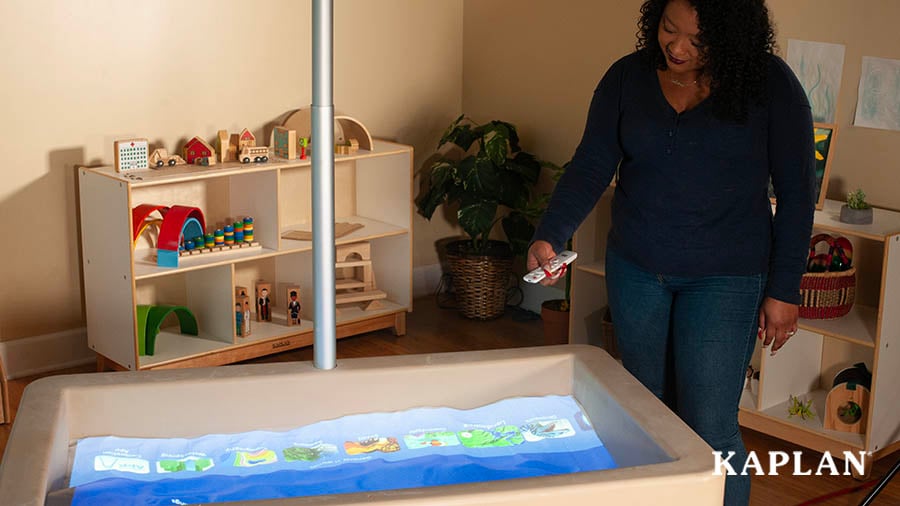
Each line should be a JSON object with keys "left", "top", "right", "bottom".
{"left": 606, "top": 250, "right": 766, "bottom": 506}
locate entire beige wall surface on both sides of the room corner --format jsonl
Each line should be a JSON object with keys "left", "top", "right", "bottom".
{"left": 0, "top": 0, "right": 900, "bottom": 341}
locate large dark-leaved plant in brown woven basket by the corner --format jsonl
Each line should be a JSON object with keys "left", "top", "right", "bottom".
{"left": 415, "top": 115, "right": 556, "bottom": 320}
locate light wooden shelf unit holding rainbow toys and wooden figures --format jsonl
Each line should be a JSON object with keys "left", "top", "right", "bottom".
{"left": 78, "top": 141, "right": 413, "bottom": 370}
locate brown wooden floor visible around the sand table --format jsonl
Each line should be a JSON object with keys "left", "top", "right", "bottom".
{"left": 0, "top": 298, "right": 900, "bottom": 506}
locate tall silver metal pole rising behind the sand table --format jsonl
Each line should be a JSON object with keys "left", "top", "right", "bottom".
{"left": 310, "top": 0, "right": 337, "bottom": 369}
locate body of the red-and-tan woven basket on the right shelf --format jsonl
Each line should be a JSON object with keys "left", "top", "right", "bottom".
{"left": 800, "top": 267, "right": 856, "bottom": 320}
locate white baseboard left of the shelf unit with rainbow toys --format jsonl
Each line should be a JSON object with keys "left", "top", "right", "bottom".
{"left": 0, "top": 328, "right": 97, "bottom": 379}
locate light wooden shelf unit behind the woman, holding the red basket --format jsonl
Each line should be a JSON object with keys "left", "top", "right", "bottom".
{"left": 569, "top": 196, "right": 900, "bottom": 469}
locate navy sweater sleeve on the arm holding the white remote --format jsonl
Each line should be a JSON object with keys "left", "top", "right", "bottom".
{"left": 532, "top": 57, "right": 627, "bottom": 252}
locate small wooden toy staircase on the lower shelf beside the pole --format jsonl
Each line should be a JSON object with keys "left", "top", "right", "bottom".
{"left": 334, "top": 241, "right": 387, "bottom": 312}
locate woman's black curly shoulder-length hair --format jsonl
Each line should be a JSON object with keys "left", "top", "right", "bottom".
{"left": 636, "top": 0, "right": 775, "bottom": 122}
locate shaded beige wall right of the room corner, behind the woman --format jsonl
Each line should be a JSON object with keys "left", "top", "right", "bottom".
{"left": 463, "top": 0, "right": 900, "bottom": 209}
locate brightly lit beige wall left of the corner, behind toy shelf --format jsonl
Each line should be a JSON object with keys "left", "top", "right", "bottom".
{"left": 0, "top": 0, "right": 462, "bottom": 341}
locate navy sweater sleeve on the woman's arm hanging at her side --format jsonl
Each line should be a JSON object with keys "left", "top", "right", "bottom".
{"left": 766, "top": 57, "right": 816, "bottom": 304}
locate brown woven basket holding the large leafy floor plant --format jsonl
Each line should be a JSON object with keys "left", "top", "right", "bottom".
{"left": 447, "top": 241, "right": 513, "bottom": 320}
